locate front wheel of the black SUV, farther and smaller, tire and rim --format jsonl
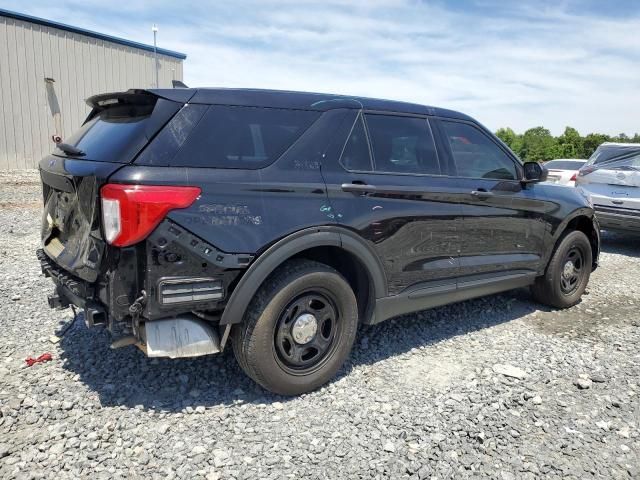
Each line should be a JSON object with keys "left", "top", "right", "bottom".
{"left": 531, "top": 230, "right": 592, "bottom": 308}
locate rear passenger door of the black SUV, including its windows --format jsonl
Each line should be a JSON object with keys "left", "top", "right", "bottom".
{"left": 323, "top": 112, "right": 461, "bottom": 294}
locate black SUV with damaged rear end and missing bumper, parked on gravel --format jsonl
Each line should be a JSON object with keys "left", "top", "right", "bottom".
{"left": 38, "top": 89, "right": 599, "bottom": 394}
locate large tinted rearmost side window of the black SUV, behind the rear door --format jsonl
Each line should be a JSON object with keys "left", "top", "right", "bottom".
{"left": 172, "top": 105, "right": 320, "bottom": 168}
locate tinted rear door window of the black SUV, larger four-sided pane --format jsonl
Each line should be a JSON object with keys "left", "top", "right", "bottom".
{"left": 366, "top": 114, "right": 440, "bottom": 174}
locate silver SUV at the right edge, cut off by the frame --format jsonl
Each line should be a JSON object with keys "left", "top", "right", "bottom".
{"left": 576, "top": 143, "right": 640, "bottom": 233}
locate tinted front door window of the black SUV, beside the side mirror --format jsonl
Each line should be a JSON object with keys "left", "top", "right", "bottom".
{"left": 442, "top": 122, "right": 518, "bottom": 180}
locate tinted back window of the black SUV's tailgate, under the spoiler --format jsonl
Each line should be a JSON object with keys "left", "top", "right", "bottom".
{"left": 56, "top": 104, "right": 154, "bottom": 163}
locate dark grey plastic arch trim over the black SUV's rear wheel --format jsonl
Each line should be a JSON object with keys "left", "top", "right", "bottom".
{"left": 220, "top": 226, "right": 387, "bottom": 325}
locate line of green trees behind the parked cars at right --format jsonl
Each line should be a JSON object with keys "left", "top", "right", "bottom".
{"left": 496, "top": 127, "right": 640, "bottom": 162}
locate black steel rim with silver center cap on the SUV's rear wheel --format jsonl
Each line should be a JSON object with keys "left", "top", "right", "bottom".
{"left": 274, "top": 292, "right": 339, "bottom": 374}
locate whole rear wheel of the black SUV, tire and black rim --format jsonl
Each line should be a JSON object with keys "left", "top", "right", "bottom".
{"left": 232, "top": 260, "right": 358, "bottom": 395}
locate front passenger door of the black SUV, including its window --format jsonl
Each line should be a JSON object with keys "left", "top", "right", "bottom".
{"left": 437, "top": 119, "right": 554, "bottom": 285}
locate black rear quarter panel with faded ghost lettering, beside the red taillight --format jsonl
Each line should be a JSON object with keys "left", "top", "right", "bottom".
{"left": 111, "top": 165, "right": 334, "bottom": 254}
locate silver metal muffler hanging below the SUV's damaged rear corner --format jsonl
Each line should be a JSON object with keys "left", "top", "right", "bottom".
{"left": 140, "top": 314, "right": 220, "bottom": 358}
